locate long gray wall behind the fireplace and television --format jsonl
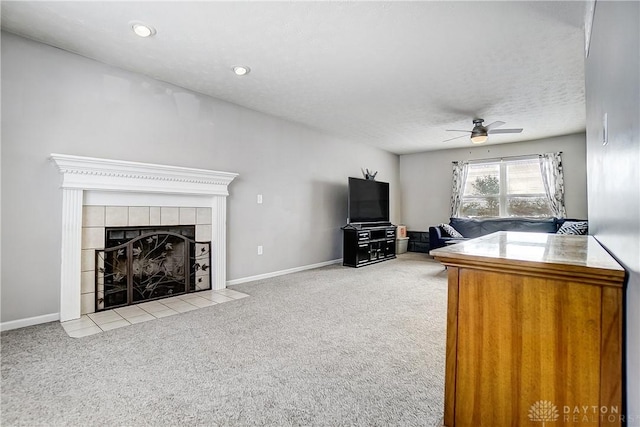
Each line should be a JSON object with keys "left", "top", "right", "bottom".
{"left": 1, "top": 32, "right": 400, "bottom": 322}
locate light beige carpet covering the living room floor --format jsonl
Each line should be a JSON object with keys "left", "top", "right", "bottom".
{"left": 0, "top": 253, "right": 447, "bottom": 426}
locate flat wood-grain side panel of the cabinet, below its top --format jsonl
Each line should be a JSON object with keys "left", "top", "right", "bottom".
{"left": 455, "top": 268, "right": 601, "bottom": 426}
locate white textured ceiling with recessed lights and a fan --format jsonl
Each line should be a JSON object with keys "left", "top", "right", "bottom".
{"left": 1, "top": 1, "right": 585, "bottom": 154}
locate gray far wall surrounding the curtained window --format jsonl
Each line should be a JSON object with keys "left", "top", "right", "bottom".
{"left": 400, "top": 133, "right": 587, "bottom": 231}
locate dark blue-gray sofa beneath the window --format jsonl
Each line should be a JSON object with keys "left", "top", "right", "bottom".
{"left": 429, "top": 218, "right": 586, "bottom": 250}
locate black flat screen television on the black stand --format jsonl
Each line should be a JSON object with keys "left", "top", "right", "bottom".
{"left": 349, "top": 178, "right": 389, "bottom": 222}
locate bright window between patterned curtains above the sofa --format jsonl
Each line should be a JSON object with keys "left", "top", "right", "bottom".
{"left": 458, "top": 155, "right": 554, "bottom": 217}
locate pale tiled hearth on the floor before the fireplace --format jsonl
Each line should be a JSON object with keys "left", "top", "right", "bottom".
{"left": 61, "top": 289, "right": 249, "bottom": 338}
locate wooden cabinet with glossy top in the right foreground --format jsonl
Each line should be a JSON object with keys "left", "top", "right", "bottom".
{"left": 431, "top": 232, "right": 625, "bottom": 427}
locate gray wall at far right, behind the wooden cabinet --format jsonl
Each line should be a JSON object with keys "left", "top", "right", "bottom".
{"left": 585, "top": 1, "right": 640, "bottom": 414}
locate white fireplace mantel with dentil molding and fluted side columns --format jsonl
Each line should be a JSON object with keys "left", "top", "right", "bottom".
{"left": 51, "top": 154, "right": 238, "bottom": 321}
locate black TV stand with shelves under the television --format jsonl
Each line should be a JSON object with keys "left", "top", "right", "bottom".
{"left": 342, "top": 223, "right": 396, "bottom": 268}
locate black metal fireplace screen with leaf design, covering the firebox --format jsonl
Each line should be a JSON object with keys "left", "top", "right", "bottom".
{"left": 96, "top": 226, "right": 211, "bottom": 311}
